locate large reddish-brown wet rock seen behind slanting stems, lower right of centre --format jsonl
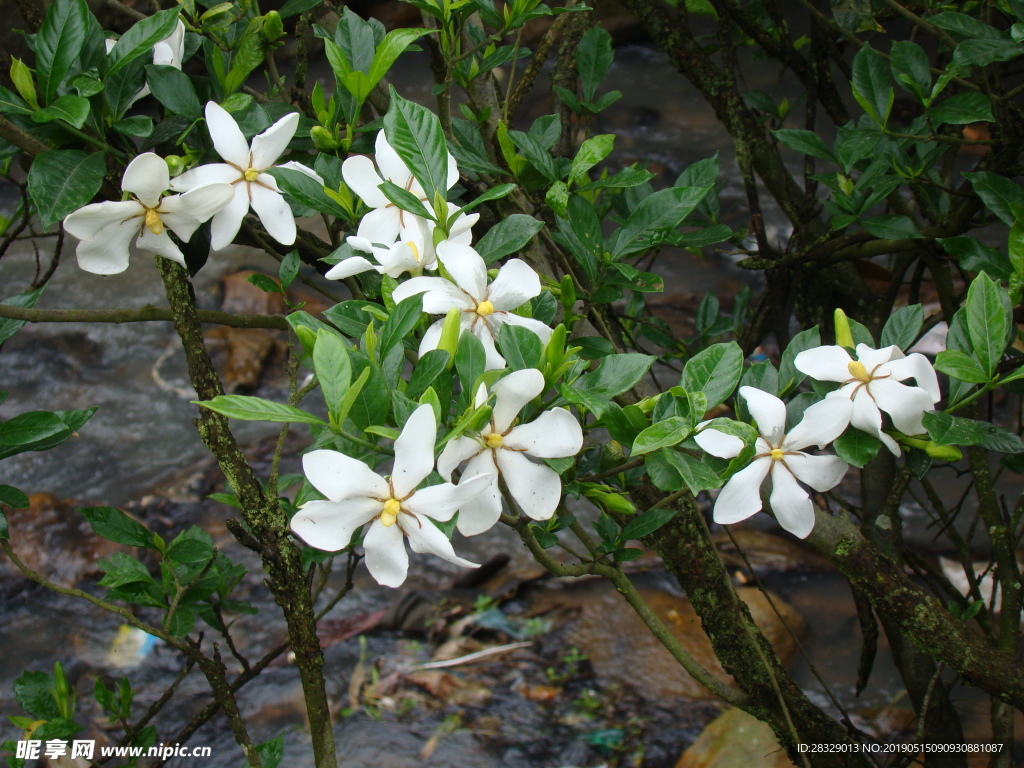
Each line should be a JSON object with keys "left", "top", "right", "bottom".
{"left": 531, "top": 580, "right": 804, "bottom": 700}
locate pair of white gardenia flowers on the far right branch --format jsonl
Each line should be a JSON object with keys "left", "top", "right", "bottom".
{"left": 695, "top": 344, "right": 939, "bottom": 539}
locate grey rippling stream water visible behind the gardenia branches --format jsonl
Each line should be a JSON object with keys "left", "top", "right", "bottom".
{"left": 0, "top": 40, "right": 1015, "bottom": 768}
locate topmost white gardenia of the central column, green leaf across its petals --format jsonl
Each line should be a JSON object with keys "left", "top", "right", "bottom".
{"left": 341, "top": 131, "right": 480, "bottom": 249}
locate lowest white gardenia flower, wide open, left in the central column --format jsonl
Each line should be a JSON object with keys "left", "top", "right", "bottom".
{"left": 292, "top": 404, "right": 486, "bottom": 587}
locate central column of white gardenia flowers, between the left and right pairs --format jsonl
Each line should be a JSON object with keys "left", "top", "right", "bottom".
{"left": 292, "top": 131, "right": 583, "bottom": 587}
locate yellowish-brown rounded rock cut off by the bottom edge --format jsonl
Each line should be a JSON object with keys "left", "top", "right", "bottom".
{"left": 676, "top": 710, "right": 794, "bottom": 768}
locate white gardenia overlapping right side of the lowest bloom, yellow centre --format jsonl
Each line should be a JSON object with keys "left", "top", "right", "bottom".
{"left": 437, "top": 368, "right": 583, "bottom": 536}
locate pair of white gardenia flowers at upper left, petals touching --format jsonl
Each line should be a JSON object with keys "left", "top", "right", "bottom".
{"left": 63, "top": 99, "right": 323, "bottom": 274}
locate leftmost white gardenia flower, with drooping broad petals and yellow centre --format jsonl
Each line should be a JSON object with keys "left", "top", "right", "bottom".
{"left": 63, "top": 153, "right": 234, "bottom": 274}
